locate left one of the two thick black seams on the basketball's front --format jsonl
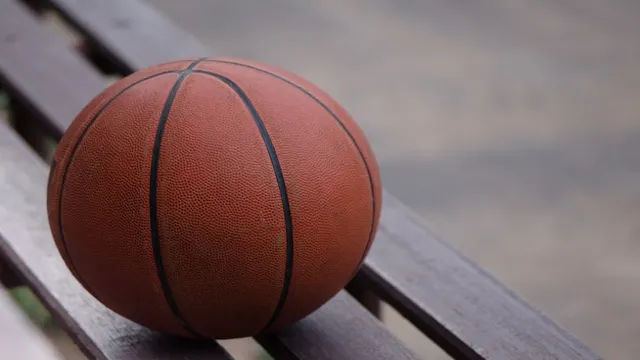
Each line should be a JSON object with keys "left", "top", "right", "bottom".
{"left": 149, "top": 58, "right": 206, "bottom": 338}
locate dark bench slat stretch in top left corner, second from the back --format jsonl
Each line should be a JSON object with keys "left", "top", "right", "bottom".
{"left": 0, "top": 0, "right": 105, "bottom": 137}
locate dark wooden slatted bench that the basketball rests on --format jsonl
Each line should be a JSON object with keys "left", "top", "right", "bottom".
{"left": 0, "top": 0, "right": 600, "bottom": 360}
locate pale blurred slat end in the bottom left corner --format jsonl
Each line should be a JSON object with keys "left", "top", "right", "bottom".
{"left": 0, "top": 288, "right": 62, "bottom": 360}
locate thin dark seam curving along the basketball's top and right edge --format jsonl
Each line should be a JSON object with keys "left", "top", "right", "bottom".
{"left": 206, "top": 59, "right": 376, "bottom": 277}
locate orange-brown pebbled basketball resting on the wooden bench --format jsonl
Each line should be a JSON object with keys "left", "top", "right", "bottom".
{"left": 47, "top": 58, "right": 381, "bottom": 339}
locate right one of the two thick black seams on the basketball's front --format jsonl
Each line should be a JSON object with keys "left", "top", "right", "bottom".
{"left": 194, "top": 70, "right": 293, "bottom": 329}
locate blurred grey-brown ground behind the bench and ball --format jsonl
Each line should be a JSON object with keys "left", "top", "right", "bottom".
{"left": 144, "top": 0, "right": 640, "bottom": 360}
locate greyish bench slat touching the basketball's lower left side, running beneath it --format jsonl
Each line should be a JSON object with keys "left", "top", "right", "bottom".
{"left": 0, "top": 123, "right": 231, "bottom": 360}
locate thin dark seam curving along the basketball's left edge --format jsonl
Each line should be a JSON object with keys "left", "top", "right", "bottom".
{"left": 58, "top": 70, "right": 179, "bottom": 298}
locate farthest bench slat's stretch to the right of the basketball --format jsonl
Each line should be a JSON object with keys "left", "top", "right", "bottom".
{"left": 363, "top": 192, "right": 601, "bottom": 360}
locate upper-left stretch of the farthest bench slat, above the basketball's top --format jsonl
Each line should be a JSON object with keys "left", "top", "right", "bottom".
{"left": 42, "top": 0, "right": 213, "bottom": 74}
